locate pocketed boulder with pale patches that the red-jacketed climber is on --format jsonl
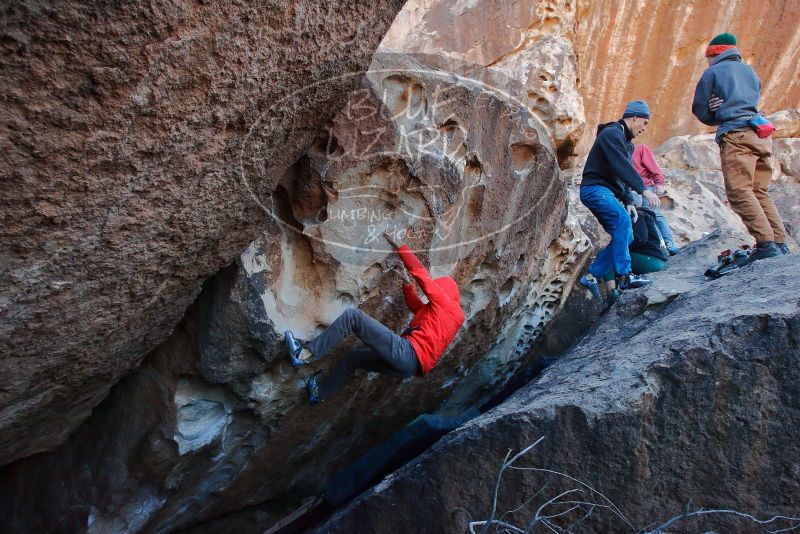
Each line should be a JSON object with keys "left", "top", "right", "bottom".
{"left": 0, "top": 56, "right": 588, "bottom": 532}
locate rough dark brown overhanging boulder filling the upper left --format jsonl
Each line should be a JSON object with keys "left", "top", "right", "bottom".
{"left": 0, "top": 0, "right": 402, "bottom": 464}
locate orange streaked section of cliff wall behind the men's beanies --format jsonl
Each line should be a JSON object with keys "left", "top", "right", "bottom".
{"left": 575, "top": 0, "right": 800, "bottom": 150}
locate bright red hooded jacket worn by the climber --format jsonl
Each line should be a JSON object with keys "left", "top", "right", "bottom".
{"left": 397, "top": 245, "right": 464, "bottom": 374}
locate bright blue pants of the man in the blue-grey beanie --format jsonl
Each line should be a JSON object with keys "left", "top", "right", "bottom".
{"left": 581, "top": 185, "right": 633, "bottom": 280}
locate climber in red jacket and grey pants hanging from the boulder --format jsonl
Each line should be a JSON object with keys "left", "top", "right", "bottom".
{"left": 284, "top": 232, "right": 464, "bottom": 404}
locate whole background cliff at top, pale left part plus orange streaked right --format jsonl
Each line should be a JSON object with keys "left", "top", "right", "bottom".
{"left": 382, "top": 0, "right": 800, "bottom": 152}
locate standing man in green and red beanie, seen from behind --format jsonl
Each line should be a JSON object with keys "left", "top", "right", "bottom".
{"left": 692, "top": 33, "right": 789, "bottom": 261}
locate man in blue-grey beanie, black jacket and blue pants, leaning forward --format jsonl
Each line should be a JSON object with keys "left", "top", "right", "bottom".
{"left": 581, "top": 100, "right": 661, "bottom": 310}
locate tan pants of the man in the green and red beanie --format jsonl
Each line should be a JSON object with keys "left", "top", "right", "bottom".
{"left": 720, "top": 130, "right": 786, "bottom": 243}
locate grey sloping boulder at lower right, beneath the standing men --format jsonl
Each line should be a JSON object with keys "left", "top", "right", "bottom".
{"left": 318, "top": 235, "right": 800, "bottom": 533}
